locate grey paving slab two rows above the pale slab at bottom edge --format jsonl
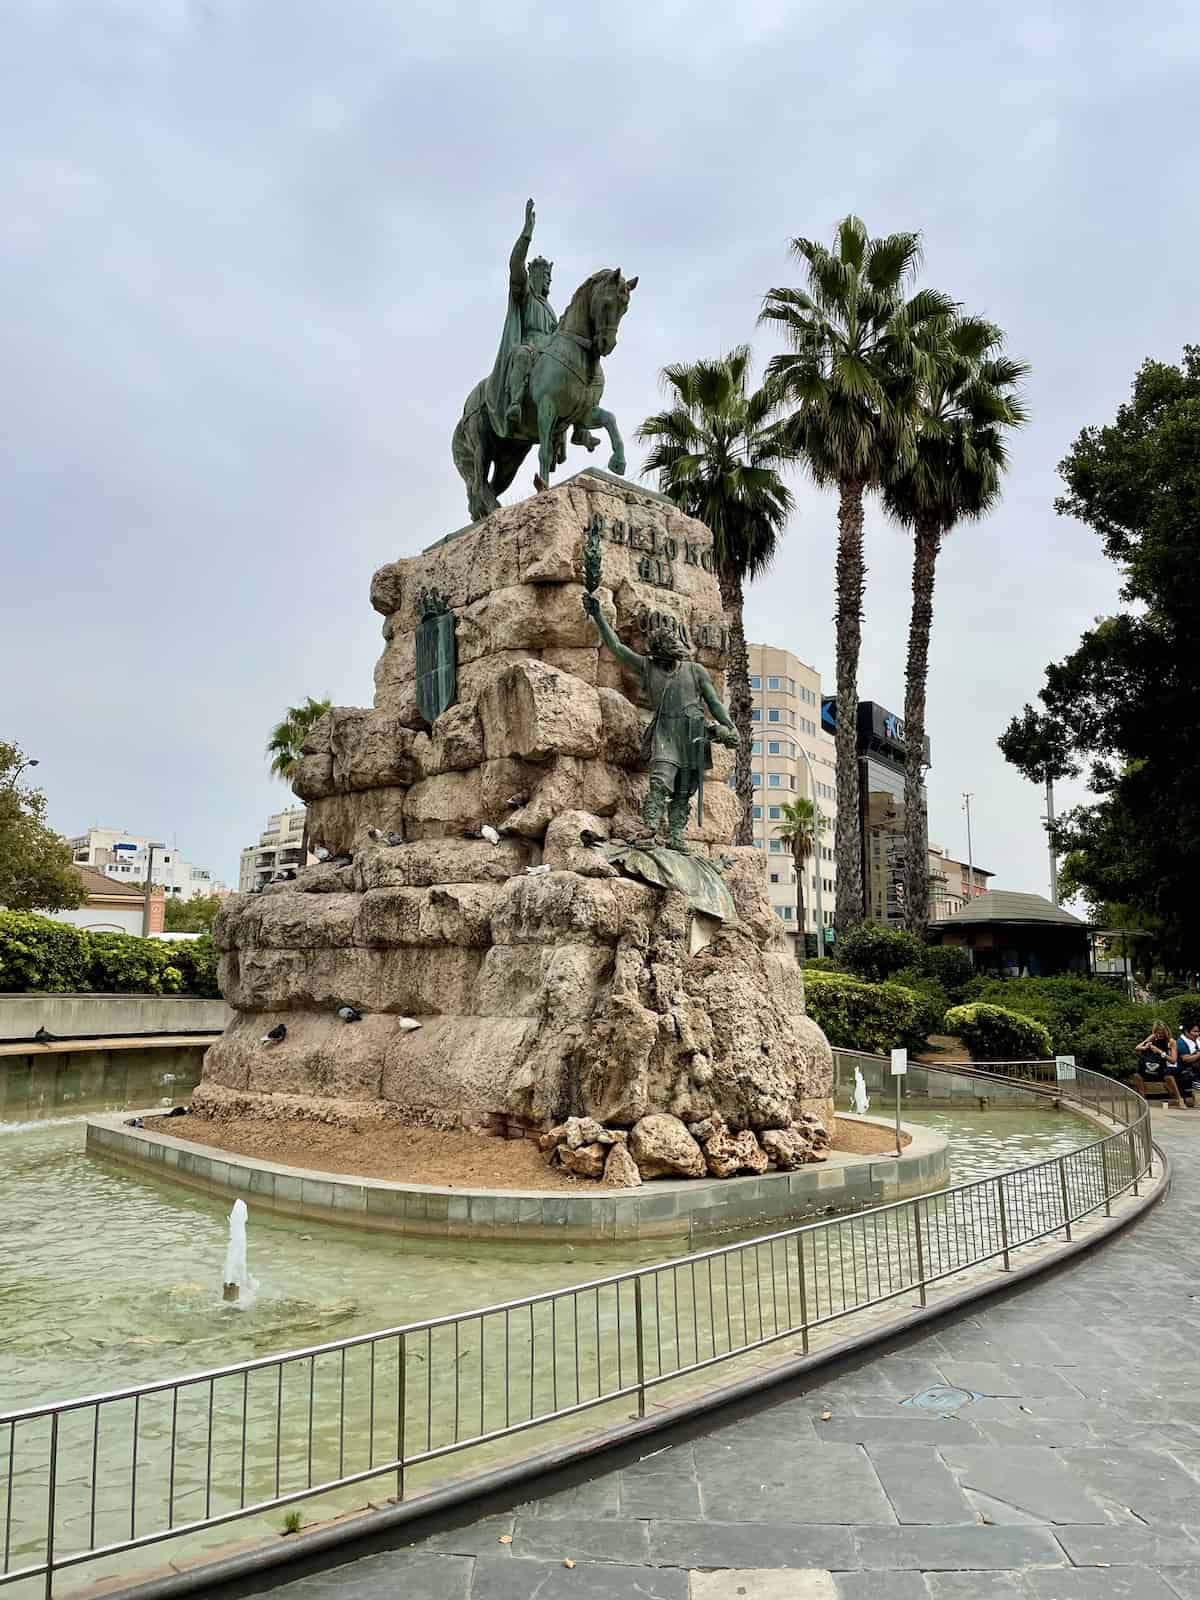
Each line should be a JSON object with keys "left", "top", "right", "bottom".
{"left": 696, "top": 1443, "right": 896, "bottom": 1523}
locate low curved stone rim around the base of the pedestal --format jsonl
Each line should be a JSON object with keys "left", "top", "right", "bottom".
{"left": 86, "top": 1112, "right": 950, "bottom": 1251}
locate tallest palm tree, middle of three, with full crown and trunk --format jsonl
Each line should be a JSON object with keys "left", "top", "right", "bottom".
{"left": 758, "top": 216, "right": 954, "bottom": 936}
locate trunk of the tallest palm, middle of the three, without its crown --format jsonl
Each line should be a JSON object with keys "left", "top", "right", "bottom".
{"left": 834, "top": 478, "right": 866, "bottom": 938}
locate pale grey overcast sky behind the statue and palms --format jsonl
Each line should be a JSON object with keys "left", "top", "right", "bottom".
{"left": 0, "top": 0, "right": 1200, "bottom": 893}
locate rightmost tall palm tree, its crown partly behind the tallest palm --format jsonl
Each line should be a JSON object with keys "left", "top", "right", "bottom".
{"left": 883, "top": 317, "right": 1029, "bottom": 938}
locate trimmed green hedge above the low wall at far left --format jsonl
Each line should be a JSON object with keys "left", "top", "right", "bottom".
{"left": 0, "top": 910, "right": 221, "bottom": 997}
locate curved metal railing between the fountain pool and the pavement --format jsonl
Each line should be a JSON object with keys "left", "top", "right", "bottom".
{"left": 0, "top": 1051, "right": 1152, "bottom": 1597}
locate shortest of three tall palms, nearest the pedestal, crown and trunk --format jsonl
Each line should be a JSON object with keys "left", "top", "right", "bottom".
{"left": 637, "top": 344, "right": 792, "bottom": 845}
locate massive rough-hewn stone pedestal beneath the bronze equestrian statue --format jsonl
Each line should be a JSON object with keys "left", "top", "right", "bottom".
{"left": 195, "top": 474, "right": 832, "bottom": 1130}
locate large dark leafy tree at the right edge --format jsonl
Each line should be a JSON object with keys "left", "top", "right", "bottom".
{"left": 998, "top": 346, "right": 1200, "bottom": 973}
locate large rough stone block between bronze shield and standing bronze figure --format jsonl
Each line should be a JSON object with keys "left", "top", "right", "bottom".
{"left": 480, "top": 661, "right": 600, "bottom": 762}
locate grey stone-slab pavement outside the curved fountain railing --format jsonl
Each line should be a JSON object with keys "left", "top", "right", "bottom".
{"left": 249, "top": 1110, "right": 1200, "bottom": 1600}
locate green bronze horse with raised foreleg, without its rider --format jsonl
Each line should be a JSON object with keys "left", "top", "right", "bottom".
{"left": 451, "top": 267, "right": 637, "bottom": 522}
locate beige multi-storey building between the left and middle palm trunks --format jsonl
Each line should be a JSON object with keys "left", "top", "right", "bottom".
{"left": 747, "top": 645, "right": 837, "bottom": 949}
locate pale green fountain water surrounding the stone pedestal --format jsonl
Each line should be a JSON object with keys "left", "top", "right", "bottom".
{"left": 0, "top": 1058, "right": 1096, "bottom": 1595}
